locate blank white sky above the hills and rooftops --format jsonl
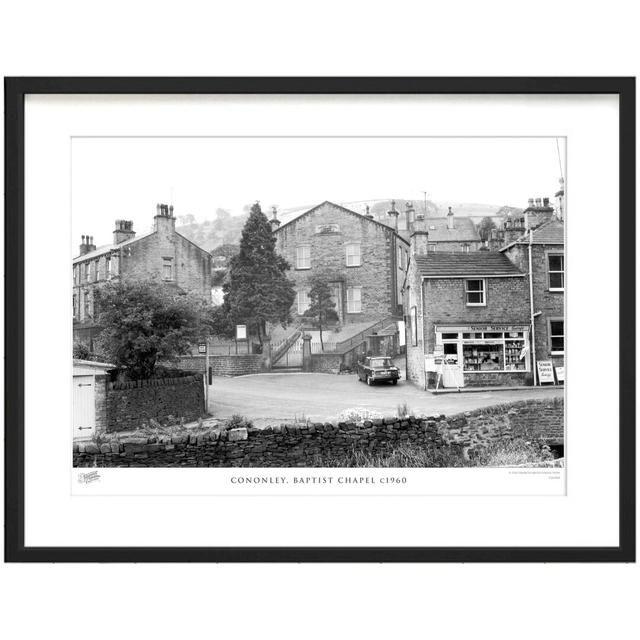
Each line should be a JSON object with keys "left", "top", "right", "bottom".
{"left": 71, "top": 137, "right": 565, "bottom": 255}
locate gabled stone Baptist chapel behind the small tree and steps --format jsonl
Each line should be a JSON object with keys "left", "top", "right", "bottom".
{"left": 271, "top": 201, "right": 409, "bottom": 323}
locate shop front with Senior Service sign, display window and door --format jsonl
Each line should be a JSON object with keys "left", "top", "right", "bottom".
{"left": 434, "top": 324, "right": 533, "bottom": 386}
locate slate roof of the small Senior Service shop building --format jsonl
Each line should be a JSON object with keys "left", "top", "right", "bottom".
{"left": 415, "top": 251, "right": 525, "bottom": 278}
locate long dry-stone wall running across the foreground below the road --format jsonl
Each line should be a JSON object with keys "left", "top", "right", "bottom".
{"left": 73, "top": 398, "right": 564, "bottom": 467}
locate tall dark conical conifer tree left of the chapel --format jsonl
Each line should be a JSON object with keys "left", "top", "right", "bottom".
{"left": 223, "top": 202, "right": 295, "bottom": 344}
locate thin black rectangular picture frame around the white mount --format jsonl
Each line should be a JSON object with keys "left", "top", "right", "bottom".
{"left": 4, "top": 77, "right": 636, "bottom": 562}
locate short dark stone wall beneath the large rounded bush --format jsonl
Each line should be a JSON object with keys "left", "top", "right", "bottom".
{"left": 105, "top": 374, "right": 205, "bottom": 432}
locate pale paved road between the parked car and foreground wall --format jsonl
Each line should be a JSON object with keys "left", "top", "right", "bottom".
{"left": 209, "top": 373, "right": 563, "bottom": 426}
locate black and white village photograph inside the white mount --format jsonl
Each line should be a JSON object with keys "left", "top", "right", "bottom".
{"left": 69, "top": 136, "right": 572, "bottom": 472}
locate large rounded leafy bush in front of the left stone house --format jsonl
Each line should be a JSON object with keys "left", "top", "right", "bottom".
{"left": 95, "top": 280, "right": 213, "bottom": 380}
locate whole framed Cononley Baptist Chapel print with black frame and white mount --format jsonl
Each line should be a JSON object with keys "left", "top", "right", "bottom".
{"left": 5, "top": 78, "right": 635, "bottom": 562}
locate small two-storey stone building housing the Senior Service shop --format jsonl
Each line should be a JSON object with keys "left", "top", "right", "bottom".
{"left": 404, "top": 229, "right": 532, "bottom": 389}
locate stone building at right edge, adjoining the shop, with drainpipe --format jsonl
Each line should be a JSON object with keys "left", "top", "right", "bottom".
{"left": 501, "top": 217, "right": 565, "bottom": 382}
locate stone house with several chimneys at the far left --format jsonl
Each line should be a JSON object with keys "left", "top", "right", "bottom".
{"left": 73, "top": 204, "right": 211, "bottom": 343}
